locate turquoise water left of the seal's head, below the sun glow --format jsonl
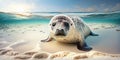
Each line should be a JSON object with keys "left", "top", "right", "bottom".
{"left": 0, "top": 13, "right": 49, "bottom": 24}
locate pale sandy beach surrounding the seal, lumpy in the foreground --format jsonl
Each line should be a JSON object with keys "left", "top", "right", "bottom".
{"left": 0, "top": 24, "right": 120, "bottom": 60}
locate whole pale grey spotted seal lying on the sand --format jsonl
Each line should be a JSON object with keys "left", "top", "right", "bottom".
{"left": 41, "top": 14, "right": 97, "bottom": 50}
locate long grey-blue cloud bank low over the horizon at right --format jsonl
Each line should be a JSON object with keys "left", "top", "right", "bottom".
{"left": 61, "top": 3, "right": 120, "bottom": 12}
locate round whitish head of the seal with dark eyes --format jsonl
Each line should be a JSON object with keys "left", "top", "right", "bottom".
{"left": 50, "top": 14, "right": 73, "bottom": 36}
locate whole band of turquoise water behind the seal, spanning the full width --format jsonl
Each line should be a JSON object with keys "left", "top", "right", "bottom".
{"left": 0, "top": 12, "right": 120, "bottom": 25}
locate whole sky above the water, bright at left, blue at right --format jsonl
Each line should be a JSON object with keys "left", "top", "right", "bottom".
{"left": 0, "top": 0, "right": 120, "bottom": 12}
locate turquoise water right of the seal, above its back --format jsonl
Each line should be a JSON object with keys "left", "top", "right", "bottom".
{"left": 83, "top": 12, "right": 120, "bottom": 25}
